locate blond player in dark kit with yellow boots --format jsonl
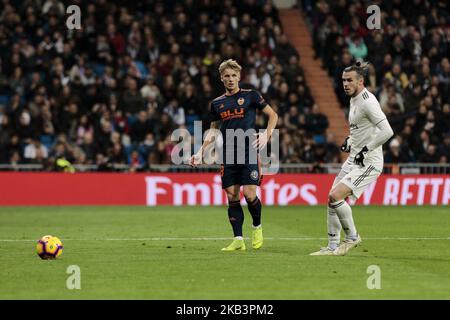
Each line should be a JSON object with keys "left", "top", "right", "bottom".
{"left": 190, "top": 59, "right": 278, "bottom": 251}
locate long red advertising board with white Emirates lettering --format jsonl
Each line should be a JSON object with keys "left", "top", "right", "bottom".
{"left": 0, "top": 172, "right": 450, "bottom": 206}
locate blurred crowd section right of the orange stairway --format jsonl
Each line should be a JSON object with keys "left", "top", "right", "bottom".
{"left": 303, "top": 0, "right": 450, "bottom": 163}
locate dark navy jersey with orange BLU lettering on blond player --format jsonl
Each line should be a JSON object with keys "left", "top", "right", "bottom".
{"left": 209, "top": 89, "right": 267, "bottom": 165}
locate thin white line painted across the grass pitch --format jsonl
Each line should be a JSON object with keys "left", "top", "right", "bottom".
{"left": 0, "top": 237, "right": 450, "bottom": 242}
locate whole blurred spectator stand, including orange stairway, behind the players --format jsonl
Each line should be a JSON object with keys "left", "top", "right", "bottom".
{"left": 0, "top": 0, "right": 450, "bottom": 173}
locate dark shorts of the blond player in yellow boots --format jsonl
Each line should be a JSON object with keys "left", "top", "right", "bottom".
{"left": 220, "top": 164, "right": 262, "bottom": 189}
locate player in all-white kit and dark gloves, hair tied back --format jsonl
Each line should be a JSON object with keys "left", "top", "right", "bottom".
{"left": 311, "top": 62, "right": 394, "bottom": 256}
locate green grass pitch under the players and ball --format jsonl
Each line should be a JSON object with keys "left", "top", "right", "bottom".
{"left": 0, "top": 206, "right": 450, "bottom": 300}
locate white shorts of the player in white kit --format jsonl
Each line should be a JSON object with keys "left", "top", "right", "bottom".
{"left": 331, "top": 161, "right": 383, "bottom": 200}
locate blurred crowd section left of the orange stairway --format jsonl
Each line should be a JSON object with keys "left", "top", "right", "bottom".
{"left": 0, "top": 0, "right": 339, "bottom": 171}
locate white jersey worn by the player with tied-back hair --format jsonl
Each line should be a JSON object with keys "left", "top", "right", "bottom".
{"left": 347, "top": 88, "right": 387, "bottom": 171}
